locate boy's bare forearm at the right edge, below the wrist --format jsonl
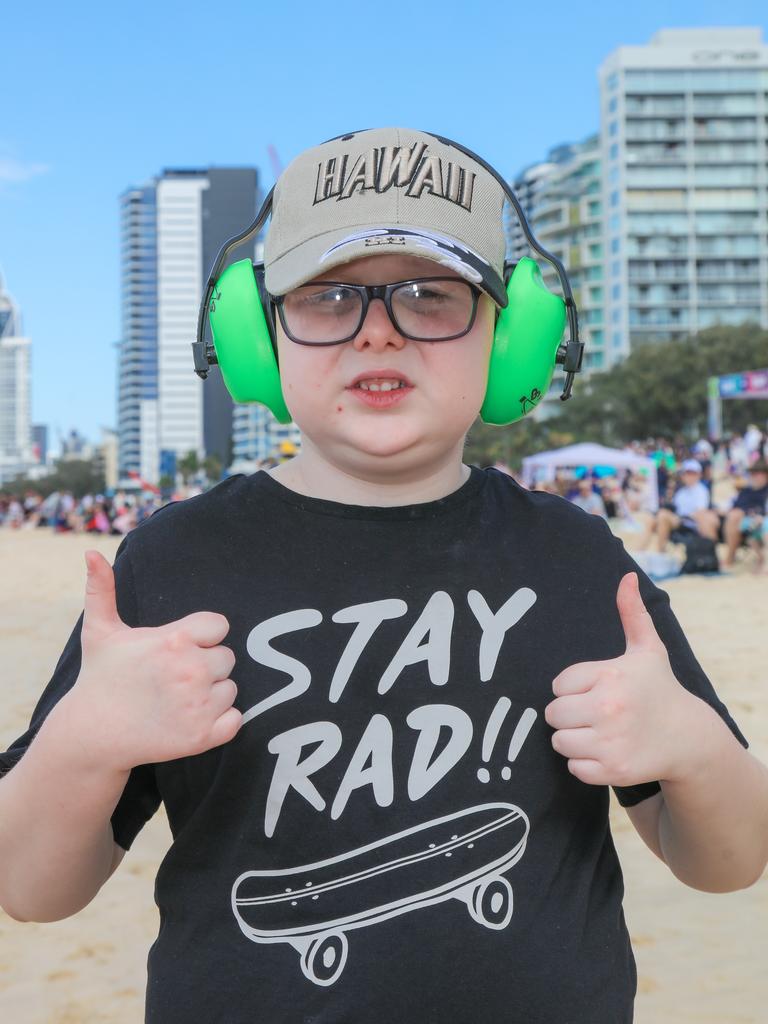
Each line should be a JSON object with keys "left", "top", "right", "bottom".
{"left": 658, "top": 701, "right": 768, "bottom": 892}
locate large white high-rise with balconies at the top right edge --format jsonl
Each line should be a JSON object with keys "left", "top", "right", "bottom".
{"left": 599, "top": 28, "right": 768, "bottom": 365}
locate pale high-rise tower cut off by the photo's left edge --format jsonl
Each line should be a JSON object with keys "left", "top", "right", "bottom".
{"left": 0, "top": 276, "right": 36, "bottom": 484}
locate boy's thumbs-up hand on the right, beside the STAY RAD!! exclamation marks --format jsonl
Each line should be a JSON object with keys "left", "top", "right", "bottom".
{"left": 545, "top": 572, "right": 700, "bottom": 786}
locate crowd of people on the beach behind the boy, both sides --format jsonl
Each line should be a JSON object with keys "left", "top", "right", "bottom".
{"left": 0, "top": 424, "right": 768, "bottom": 570}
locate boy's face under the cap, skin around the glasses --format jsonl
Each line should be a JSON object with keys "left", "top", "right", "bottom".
{"left": 276, "top": 255, "right": 494, "bottom": 473}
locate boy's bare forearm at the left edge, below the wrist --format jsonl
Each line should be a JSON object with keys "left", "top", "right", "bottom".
{"left": 0, "top": 692, "right": 128, "bottom": 921}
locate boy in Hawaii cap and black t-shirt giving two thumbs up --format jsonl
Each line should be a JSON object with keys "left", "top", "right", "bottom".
{"left": 0, "top": 129, "right": 768, "bottom": 1024}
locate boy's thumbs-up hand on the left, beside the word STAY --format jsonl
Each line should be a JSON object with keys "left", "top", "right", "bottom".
{"left": 69, "top": 551, "right": 242, "bottom": 771}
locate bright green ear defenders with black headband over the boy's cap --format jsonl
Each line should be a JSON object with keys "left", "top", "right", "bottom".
{"left": 193, "top": 135, "right": 584, "bottom": 426}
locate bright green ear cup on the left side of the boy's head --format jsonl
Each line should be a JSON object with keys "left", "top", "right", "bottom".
{"left": 208, "top": 259, "right": 291, "bottom": 423}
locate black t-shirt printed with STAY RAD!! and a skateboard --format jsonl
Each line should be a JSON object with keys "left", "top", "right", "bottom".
{"left": 0, "top": 467, "right": 743, "bottom": 1024}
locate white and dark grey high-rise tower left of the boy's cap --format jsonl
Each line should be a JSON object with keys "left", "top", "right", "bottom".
{"left": 118, "top": 167, "right": 258, "bottom": 483}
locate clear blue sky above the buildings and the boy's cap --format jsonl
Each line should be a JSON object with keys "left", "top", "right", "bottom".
{"left": 0, "top": 0, "right": 768, "bottom": 446}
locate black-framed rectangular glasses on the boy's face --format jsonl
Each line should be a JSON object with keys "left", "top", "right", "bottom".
{"left": 272, "top": 276, "right": 482, "bottom": 345}
